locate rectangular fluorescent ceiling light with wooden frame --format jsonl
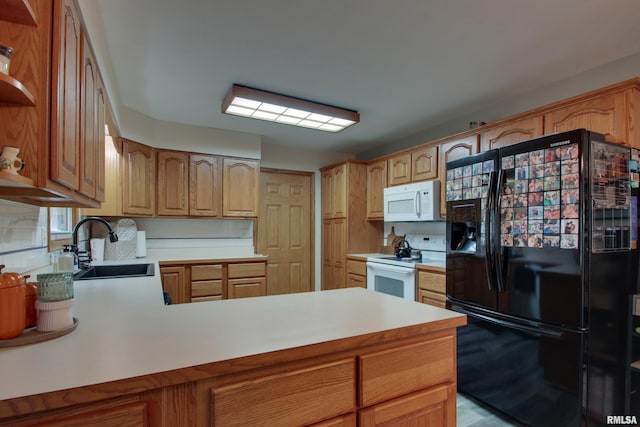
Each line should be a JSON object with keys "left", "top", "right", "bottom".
{"left": 222, "top": 84, "right": 360, "bottom": 132}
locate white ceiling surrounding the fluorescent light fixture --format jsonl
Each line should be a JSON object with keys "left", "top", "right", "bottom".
{"left": 94, "top": 0, "right": 640, "bottom": 153}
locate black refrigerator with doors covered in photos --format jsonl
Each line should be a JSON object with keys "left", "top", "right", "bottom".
{"left": 446, "top": 129, "right": 638, "bottom": 426}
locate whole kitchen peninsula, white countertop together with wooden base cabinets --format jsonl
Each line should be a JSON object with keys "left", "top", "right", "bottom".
{"left": 0, "top": 265, "right": 466, "bottom": 426}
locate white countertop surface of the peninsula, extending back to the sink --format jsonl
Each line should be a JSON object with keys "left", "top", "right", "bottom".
{"left": 0, "top": 255, "right": 461, "bottom": 400}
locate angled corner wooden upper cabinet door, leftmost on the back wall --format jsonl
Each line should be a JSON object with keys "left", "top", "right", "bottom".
{"left": 122, "top": 140, "right": 156, "bottom": 216}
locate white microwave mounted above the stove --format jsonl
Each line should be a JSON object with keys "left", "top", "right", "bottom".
{"left": 384, "top": 181, "right": 440, "bottom": 222}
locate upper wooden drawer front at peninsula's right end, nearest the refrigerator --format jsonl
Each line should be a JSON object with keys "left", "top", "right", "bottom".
{"left": 359, "top": 335, "right": 456, "bottom": 406}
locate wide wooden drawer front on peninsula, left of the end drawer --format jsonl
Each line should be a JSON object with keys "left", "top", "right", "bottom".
{"left": 211, "top": 359, "right": 356, "bottom": 426}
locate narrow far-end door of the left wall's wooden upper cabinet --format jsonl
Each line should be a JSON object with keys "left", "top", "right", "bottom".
{"left": 80, "top": 33, "right": 97, "bottom": 198}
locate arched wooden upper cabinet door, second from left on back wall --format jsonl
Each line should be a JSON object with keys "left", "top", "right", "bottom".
{"left": 156, "top": 150, "right": 189, "bottom": 216}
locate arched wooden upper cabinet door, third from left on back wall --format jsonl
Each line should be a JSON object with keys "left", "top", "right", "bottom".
{"left": 189, "top": 154, "right": 222, "bottom": 217}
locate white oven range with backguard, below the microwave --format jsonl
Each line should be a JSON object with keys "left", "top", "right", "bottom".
{"left": 367, "top": 234, "right": 446, "bottom": 301}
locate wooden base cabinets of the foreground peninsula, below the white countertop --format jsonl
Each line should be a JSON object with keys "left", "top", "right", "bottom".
{"left": 0, "top": 322, "right": 461, "bottom": 427}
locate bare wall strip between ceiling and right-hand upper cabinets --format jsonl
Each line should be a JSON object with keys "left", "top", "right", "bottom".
{"left": 356, "top": 54, "right": 640, "bottom": 160}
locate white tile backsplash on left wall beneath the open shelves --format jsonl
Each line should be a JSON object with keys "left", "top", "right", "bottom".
{"left": 0, "top": 200, "right": 49, "bottom": 273}
